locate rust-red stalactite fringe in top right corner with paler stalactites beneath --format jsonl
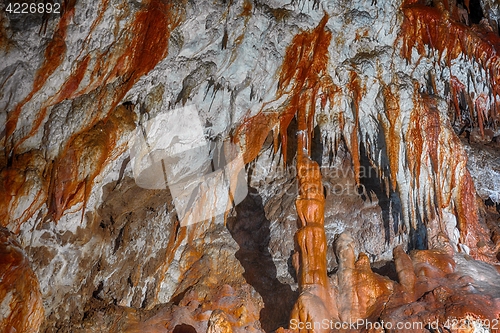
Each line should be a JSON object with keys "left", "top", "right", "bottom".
{"left": 401, "top": 0, "right": 500, "bottom": 138}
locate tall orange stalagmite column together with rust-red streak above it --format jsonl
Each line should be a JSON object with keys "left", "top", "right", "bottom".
{"left": 231, "top": 15, "right": 340, "bottom": 328}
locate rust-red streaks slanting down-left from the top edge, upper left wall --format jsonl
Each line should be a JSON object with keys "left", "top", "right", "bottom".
{"left": 12, "top": 0, "right": 178, "bottom": 153}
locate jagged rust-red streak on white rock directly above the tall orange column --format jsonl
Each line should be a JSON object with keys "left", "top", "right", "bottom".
{"left": 235, "top": 14, "right": 339, "bottom": 163}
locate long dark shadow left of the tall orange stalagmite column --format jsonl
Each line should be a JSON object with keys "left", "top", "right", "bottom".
{"left": 227, "top": 187, "right": 298, "bottom": 332}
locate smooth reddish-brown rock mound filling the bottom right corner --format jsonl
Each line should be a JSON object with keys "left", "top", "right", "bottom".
{"left": 380, "top": 250, "right": 500, "bottom": 332}
